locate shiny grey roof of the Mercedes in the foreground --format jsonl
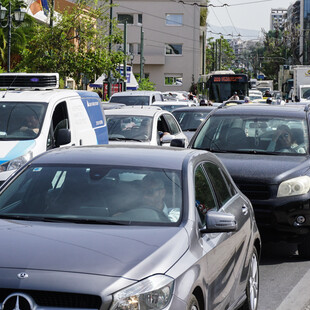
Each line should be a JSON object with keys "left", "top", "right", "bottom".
{"left": 32, "top": 145, "right": 213, "bottom": 170}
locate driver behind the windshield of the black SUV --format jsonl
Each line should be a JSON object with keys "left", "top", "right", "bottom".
{"left": 267, "top": 125, "right": 306, "bottom": 153}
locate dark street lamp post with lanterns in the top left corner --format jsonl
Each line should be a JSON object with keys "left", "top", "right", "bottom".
{"left": 0, "top": 1, "right": 26, "bottom": 72}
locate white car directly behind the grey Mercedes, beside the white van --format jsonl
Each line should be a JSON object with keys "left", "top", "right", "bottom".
{"left": 105, "top": 106, "right": 188, "bottom": 147}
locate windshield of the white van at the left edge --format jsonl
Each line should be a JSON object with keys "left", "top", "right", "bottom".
{"left": 0, "top": 102, "right": 47, "bottom": 140}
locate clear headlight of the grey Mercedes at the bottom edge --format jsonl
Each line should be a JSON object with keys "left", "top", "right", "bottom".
{"left": 111, "top": 275, "right": 174, "bottom": 310}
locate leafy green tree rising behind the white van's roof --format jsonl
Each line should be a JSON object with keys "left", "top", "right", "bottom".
{"left": 19, "top": 0, "right": 124, "bottom": 85}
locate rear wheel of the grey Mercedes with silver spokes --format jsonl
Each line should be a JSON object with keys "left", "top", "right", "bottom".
{"left": 241, "top": 248, "right": 259, "bottom": 310}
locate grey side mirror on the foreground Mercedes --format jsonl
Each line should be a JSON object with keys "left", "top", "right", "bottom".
{"left": 200, "top": 211, "right": 238, "bottom": 233}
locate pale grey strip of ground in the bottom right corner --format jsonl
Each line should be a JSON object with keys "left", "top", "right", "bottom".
{"left": 276, "top": 270, "right": 310, "bottom": 310}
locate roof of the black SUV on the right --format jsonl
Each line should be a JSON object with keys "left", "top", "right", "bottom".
{"left": 213, "top": 104, "right": 306, "bottom": 117}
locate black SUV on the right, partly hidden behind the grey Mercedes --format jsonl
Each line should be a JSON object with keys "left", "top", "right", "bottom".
{"left": 189, "top": 104, "right": 310, "bottom": 259}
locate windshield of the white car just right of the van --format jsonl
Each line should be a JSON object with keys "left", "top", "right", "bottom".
{"left": 106, "top": 115, "right": 152, "bottom": 141}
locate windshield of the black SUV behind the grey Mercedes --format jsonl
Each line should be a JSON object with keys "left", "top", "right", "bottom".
{"left": 193, "top": 115, "right": 309, "bottom": 155}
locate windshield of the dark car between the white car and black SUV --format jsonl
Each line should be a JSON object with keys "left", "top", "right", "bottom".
{"left": 173, "top": 110, "right": 211, "bottom": 130}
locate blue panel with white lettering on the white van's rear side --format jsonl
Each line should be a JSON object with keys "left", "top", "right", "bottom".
{"left": 77, "top": 91, "right": 109, "bottom": 144}
